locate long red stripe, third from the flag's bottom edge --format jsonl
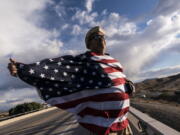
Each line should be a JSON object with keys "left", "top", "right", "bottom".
{"left": 55, "top": 93, "right": 129, "bottom": 109}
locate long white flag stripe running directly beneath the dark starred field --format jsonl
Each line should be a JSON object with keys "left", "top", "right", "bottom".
{"left": 46, "top": 87, "right": 124, "bottom": 105}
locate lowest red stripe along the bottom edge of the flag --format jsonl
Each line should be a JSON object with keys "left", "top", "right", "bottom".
{"left": 79, "top": 119, "right": 129, "bottom": 135}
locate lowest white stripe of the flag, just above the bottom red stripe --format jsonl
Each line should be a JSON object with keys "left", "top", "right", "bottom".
{"left": 78, "top": 113, "right": 128, "bottom": 127}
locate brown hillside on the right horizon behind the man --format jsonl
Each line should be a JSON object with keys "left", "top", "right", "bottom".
{"left": 135, "top": 74, "right": 180, "bottom": 92}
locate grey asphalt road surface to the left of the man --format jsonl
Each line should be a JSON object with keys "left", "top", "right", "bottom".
{"left": 0, "top": 109, "right": 89, "bottom": 135}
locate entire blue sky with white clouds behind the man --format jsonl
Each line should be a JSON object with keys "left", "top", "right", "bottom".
{"left": 0, "top": 0, "right": 180, "bottom": 110}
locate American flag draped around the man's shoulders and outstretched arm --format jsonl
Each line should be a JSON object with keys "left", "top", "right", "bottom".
{"left": 17, "top": 52, "right": 129, "bottom": 135}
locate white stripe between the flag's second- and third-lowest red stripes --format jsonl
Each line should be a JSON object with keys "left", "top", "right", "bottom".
{"left": 67, "top": 99, "right": 129, "bottom": 114}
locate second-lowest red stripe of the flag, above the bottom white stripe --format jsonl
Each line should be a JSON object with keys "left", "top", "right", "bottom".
{"left": 78, "top": 107, "right": 129, "bottom": 118}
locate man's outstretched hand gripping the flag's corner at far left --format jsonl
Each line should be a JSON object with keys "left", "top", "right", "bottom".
{"left": 7, "top": 58, "right": 17, "bottom": 77}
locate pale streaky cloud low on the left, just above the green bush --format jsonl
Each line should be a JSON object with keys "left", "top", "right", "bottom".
{"left": 0, "top": 88, "right": 43, "bottom": 111}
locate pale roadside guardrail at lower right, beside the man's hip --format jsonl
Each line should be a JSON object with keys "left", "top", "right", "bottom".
{"left": 130, "top": 107, "right": 180, "bottom": 135}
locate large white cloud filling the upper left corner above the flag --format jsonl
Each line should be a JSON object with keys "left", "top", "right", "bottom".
{"left": 0, "top": 0, "right": 63, "bottom": 60}
